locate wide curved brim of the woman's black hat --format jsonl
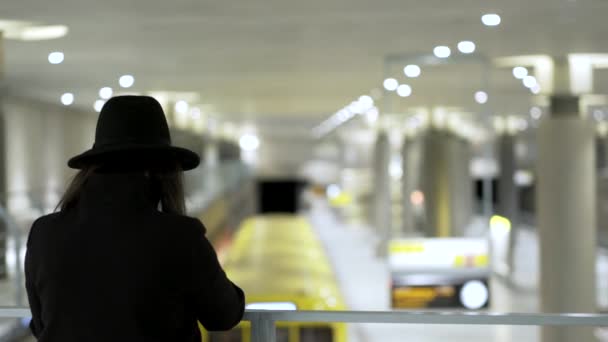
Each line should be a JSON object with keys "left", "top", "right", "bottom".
{"left": 68, "top": 144, "right": 200, "bottom": 171}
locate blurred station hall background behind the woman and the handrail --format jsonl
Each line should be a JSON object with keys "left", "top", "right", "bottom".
{"left": 0, "top": 0, "right": 608, "bottom": 342}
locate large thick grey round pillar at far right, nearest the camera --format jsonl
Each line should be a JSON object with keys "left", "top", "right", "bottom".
{"left": 537, "top": 95, "right": 596, "bottom": 342}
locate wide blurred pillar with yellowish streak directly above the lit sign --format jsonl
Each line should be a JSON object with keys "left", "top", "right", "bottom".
{"left": 420, "top": 130, "right": 473, "bottom": 237}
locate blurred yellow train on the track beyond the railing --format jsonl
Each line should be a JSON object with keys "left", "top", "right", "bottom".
{"left": 202, "top": 215, "right": 346, "bottom": 342}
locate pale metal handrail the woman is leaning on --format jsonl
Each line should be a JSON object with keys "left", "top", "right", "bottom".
{"left": 0, "top": 307, "right": 608, "bottom": 342}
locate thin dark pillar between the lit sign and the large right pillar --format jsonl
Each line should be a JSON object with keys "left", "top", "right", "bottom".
{"left": 497, "top": 133, "right": 518, "bottom": 274}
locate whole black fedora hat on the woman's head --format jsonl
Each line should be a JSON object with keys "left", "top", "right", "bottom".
{"left": 68, "top": 95, "right": 200, "bottom": 170}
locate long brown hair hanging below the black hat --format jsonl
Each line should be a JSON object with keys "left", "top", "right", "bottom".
{"left": 56, "top": 165, "right": 186, "bottom": 215}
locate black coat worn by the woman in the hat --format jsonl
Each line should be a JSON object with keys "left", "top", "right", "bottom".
{"left": 25, "top": 174, "right": 244, "bottom": 342}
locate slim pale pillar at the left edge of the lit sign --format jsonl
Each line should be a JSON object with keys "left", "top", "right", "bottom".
{"left": 373, "top": 131, "right": 392, "bottom": 256}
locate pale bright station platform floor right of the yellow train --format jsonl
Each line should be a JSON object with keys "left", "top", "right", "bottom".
{"left": 308, "top": 205, "right": 608, "bottom": 342}
